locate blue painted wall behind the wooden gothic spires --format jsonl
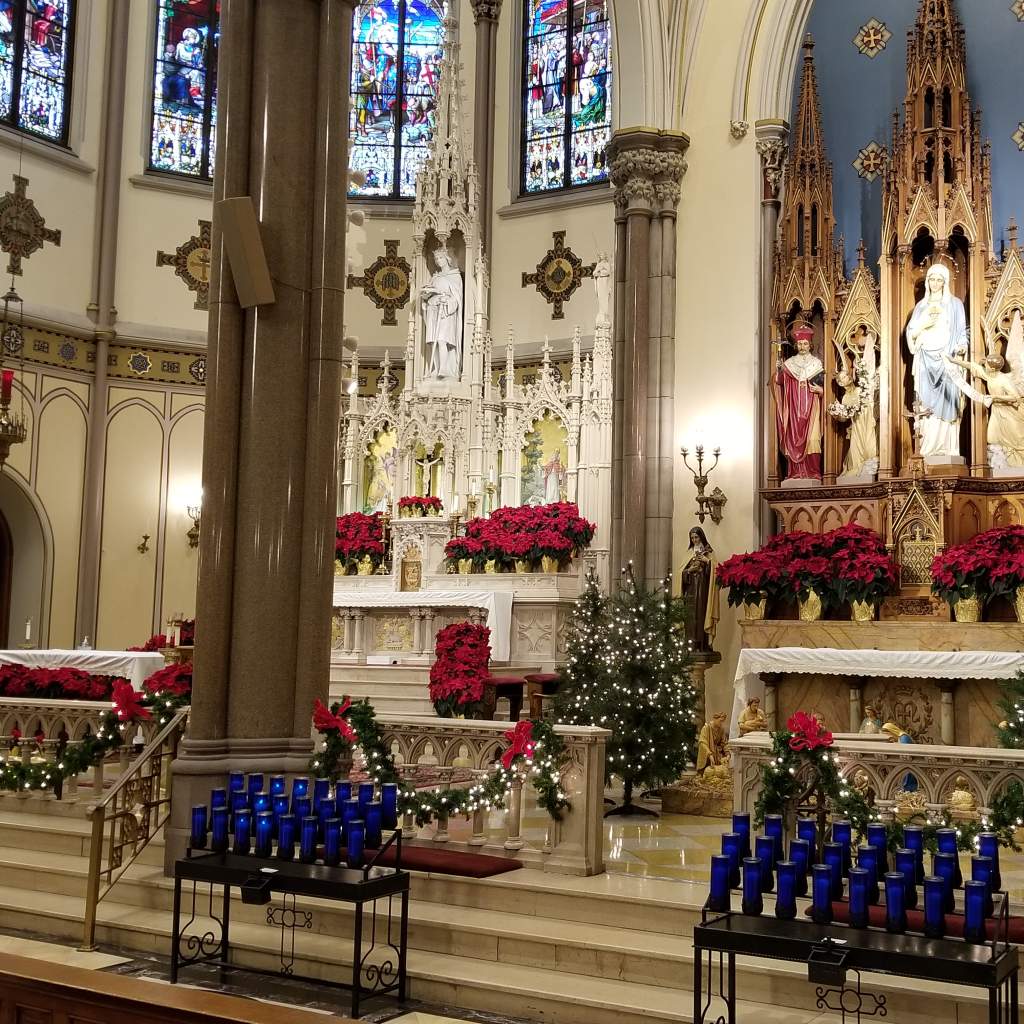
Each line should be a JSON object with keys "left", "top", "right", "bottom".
{"left": 793, "top": 0, "right": 1024, "bottom": 267}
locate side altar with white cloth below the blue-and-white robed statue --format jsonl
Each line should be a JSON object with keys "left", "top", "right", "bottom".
{"left": 730, "top": 647, "right": 1024, "bottom": 745}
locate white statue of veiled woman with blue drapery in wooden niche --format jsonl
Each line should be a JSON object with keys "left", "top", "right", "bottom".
{"left": 906, "top": 263, "right": 968, "bottom": 460}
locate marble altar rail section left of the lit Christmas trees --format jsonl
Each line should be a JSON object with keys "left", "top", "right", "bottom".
{"left": 377, "top": 715, "right": 610, "bottom": 874}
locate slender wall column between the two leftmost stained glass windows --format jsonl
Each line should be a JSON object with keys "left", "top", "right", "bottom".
{"left": 73, "top": 3, "right": 128, "bottom": 647}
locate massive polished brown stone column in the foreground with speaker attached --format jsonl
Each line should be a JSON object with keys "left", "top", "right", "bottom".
{"left": 166, "top": 0, "right": 361, "bottom": 864}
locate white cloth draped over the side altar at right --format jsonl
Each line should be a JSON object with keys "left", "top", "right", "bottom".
{"left": 729, "top": 647, "right": 1024, "bottom": 736}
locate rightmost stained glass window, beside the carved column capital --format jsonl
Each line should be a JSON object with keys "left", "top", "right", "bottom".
{"left": 521, "top": 0, "right": 611, "bottom": 193}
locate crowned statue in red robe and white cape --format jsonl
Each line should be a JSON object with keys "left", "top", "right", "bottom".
{"left": 772, "top": 325, "right": 825, "bottom": 480}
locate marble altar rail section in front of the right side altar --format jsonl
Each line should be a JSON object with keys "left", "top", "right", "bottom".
{"left": 729, "top": 732, "right": 1024, "bottom": 817}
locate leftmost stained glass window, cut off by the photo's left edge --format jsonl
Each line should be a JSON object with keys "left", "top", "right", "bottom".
{"left": 0, "top": 0, "right": 75, "bottom": 145}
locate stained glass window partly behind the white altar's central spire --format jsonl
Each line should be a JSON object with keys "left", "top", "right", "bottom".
{"left": 349, "top": 0, "right": 444, "bottom": 199}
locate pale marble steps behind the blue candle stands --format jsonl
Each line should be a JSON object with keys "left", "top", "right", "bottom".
{"left": 0, "top": 798, "right": 1015, "bottom": 1024}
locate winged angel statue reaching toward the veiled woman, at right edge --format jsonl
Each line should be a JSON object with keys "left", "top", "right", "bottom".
{"left": 947, "top": 309, "right": 1024, "bottom": 469}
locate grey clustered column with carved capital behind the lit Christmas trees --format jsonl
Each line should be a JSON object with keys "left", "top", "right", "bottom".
{"left": 608, "top": 128, "right": 689, "bottom": 585}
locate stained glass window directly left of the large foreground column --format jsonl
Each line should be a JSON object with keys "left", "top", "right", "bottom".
{"left": 148, "top": 0, "right": 220, "bottom": 179}
